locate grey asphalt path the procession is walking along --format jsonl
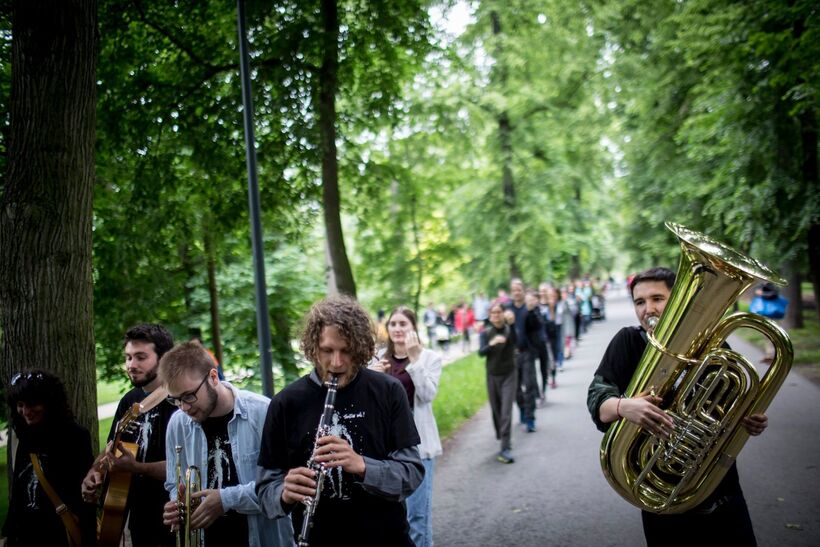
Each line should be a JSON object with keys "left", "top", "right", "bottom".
{"left": 433, "top": 295, "right": 820, "bottom": 547}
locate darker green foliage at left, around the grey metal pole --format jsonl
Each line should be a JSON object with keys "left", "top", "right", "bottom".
{"left": 87, "top": 0, "right": 438, "bottom": 379}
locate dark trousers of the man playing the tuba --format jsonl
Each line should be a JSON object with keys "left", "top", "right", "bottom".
{"left": 641, "top": 494, "right": 757, "bottom": 547}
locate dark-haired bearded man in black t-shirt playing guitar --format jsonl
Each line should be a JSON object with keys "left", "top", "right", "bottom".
{"left": 82, "top": 323, "right": 176, "bottom": 547}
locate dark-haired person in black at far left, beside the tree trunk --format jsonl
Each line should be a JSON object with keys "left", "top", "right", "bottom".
{"left": 3, "top": 370, "right": 96, "bottom": 547}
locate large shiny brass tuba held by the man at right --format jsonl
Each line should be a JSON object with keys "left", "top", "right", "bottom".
{"left": 600, "top": 222, "right": 793, "bottom": 514}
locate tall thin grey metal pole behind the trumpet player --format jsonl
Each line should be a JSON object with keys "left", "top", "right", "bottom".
{"left": 237, "top": 0, "right": 273, "bottom": 397}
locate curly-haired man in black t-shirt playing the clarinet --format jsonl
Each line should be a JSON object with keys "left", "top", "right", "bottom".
{"left": 256, "top": 297, "right": 424, "bottom": 546}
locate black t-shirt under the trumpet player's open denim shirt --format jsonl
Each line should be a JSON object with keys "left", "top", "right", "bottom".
{"left": 202, "top": 410, "right": 249, "bottom": 545}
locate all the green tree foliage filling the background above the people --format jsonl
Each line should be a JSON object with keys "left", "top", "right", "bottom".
{"left": 0, "top": 0, "right": 820, "bottom": 402}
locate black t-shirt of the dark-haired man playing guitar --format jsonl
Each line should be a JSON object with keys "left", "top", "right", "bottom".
{"left": 108, "top": 388, "right": 177, "bottom": 547}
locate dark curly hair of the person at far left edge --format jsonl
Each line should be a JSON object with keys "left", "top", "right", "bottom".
{"left": 6, "top": 369, "right": 74, "bottom": 433}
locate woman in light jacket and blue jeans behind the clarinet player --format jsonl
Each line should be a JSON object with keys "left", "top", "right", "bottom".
{"left": 370, "top": 306, "right": 441, "bottom": 547}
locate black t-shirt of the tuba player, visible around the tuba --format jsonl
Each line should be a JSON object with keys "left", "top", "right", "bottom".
{"left": 595, "top": 327, "right": 741, "bottom": 512}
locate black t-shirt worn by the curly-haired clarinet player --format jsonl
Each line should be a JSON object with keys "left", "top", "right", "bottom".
{"left": 259, "top": 369, "right": 421, "bottom": 547}
